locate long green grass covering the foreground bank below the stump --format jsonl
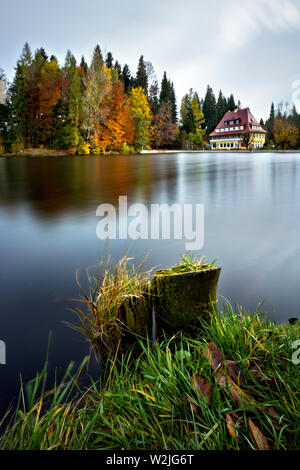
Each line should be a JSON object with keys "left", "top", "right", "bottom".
{"left": 0, "top": 304, "right": 300, "bottom": 450}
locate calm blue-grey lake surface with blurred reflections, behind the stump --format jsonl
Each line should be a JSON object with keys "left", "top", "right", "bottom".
{"left": 0, "top": 153, "right": 300, "bottom": 410}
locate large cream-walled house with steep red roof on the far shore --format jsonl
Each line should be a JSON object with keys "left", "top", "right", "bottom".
{"left": 209, "top": 108, "right": 267, "bottom": 150}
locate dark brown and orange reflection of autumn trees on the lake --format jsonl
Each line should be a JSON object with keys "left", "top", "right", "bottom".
{"left": 0, "top": 156, "right": 152, "bottom": 217}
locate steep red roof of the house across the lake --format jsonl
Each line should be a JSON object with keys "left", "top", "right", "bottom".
{"left": 209, "top": 108, "right": 267, "bottom": 137}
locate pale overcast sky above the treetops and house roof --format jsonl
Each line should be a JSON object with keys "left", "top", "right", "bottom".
{"left": 0, "top": 0, "right": 300, "bottom": 119}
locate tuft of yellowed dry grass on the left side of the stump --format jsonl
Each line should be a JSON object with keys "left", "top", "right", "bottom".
{"left": 72, "top": 256, "right": 151, "bottom": 362}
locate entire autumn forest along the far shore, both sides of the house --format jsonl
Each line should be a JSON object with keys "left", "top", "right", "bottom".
{"left": 0, "top": 43, "right": 300, "bottom": 155}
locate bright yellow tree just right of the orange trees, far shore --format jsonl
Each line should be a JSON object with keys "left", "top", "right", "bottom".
{"left": 129, "top": 87, "right": 152, "bottom": 151}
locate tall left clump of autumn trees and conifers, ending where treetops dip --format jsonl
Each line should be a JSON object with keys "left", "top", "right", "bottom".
{"left": 0, "top": 43, "right": 178, "bottom": 154}
